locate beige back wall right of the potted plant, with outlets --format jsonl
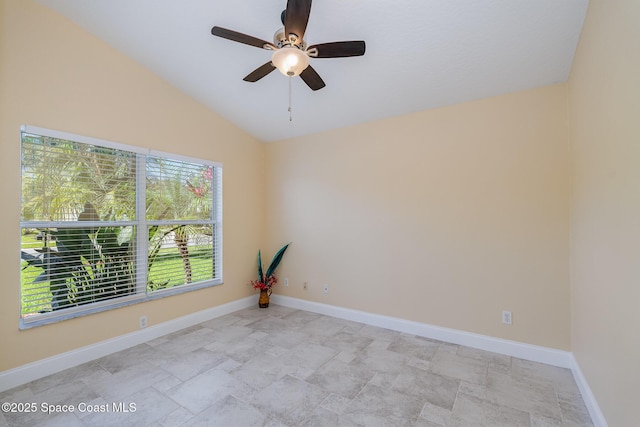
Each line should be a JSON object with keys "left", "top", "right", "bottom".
{"left": 267, "top": 84, "right": 570, "bottom": 350}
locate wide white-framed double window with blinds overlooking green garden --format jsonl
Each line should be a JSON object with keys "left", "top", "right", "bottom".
{"left": 20, "top": 126, "right": 222, "bottom": 328}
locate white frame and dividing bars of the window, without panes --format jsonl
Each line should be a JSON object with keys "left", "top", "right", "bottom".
{"left": 19, "top": 125, "right": 224, "bottom": 330}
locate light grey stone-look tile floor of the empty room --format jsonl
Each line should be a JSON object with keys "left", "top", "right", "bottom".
{"left": 0, "top": 304, "right": 592, "bottom": 427}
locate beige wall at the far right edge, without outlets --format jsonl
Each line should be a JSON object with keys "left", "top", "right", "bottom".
{"left": 569, "top": 0, "right": 640, "bottom": 426}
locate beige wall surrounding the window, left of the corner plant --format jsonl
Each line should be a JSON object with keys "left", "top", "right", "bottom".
{"left": 0, "top": 0, "right": 265, "bottom": 371}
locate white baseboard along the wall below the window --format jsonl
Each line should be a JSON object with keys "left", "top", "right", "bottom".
{"left": 0, "top": 295, "right": 256, "bottom": 392}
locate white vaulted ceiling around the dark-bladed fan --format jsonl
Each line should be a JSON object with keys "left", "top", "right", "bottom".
{"left": 36, "top": 0, "right": 588, "bottom": 141}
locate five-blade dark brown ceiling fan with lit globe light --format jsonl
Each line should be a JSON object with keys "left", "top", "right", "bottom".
{"left": 211, "top": 0, "right": 365, "bottom": 90}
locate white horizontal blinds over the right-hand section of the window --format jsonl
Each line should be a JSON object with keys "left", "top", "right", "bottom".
{"left": 146, "top": 156, "right": 219, "bottom": 290}
